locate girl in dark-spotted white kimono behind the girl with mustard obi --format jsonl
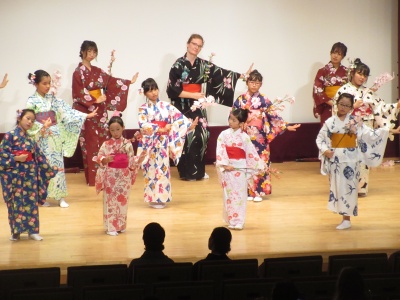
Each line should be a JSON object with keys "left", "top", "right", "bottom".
{"left": 336, "top": 58, "right": 400, "bottom": 197}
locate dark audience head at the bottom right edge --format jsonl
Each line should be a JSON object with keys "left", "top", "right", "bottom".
{"left": 333, "top": 267, "right": 367, "bottom": 300}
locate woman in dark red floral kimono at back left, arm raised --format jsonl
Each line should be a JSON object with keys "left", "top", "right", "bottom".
{"left": 72, "top": 41, "right": 138, "bottom": 186}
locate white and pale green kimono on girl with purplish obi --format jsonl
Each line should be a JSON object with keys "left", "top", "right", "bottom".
{"left": 26, "top": 92, "right": 86, "bottom": 199}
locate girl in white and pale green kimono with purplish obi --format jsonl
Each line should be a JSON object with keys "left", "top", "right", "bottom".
{"left": 26, "top": 70, "right": 97, "bottom": 208}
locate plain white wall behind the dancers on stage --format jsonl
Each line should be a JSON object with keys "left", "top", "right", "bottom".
{"left": 0, "top": 0, "right": 398, "bottom": 132}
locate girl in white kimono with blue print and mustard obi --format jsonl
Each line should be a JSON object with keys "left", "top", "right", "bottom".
{"left": 316, "top": 93, "right": 389, "bottom": 229}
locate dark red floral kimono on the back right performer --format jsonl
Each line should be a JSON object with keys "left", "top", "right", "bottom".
{"left": 313, "top": 62, "right": 348, "bottom": 124}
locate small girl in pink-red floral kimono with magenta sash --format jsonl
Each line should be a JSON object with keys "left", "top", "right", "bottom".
{"left": 96, "top": 112, "right": 145, "bottom": 236}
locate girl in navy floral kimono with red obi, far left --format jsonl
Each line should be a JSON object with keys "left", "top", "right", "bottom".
{"left": 0, "top": 109, "right": 57, "bottom": 241}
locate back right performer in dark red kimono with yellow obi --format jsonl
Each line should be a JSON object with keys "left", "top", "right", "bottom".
{"left": 313, "top": 42, "right": 347, "bottom": 127}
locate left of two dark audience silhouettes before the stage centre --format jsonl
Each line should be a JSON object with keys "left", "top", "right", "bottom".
{"left": 129, "top": 223, "right": 174, "bottom": 282}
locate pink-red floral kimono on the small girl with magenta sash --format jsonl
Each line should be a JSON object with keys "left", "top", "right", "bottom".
{"left": 95, "top": 138, "right": 139, "bottom": 232}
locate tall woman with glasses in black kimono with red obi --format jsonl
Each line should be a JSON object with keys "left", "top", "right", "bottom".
{"left": 167, "top": 34, "right": 252, "bottom": 181}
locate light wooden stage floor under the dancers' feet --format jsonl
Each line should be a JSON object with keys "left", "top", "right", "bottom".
{"left": 0, "top": 162, "right": 400, "bottom": 275}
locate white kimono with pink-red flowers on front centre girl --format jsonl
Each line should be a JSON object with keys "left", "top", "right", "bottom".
{"left": 216, "top": 128, "right": 266, "bottom": 226}
